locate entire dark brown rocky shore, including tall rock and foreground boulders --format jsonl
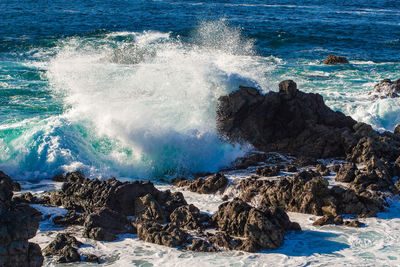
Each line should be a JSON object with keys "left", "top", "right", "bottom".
{"left": 0, "top": 80, "right": 400, "bottom": 266}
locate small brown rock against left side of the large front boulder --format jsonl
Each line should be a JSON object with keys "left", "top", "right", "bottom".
{"left": 170, "top": 204, "right": 209, "bottom": 230}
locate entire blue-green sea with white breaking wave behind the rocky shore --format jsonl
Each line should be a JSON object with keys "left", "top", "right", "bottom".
{"left": 0, "top": 0, "right": 400, "bottom": 180}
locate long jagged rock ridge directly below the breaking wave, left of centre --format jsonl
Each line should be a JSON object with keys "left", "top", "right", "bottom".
{"left": 46, "top": 172, "right": 186, "bottom": 217}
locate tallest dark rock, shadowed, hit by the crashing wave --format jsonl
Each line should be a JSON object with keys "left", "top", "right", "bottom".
{"left": 217, "top": 81, "right": 356, "bottom": 158}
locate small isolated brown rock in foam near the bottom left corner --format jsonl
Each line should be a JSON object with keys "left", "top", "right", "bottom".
{"left": 43, "top": 233, "right": 83, "bottom": 263}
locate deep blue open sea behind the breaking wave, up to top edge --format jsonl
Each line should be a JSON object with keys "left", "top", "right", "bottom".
{"left": 0, "top": 0, "right": 400, "bottom": 62}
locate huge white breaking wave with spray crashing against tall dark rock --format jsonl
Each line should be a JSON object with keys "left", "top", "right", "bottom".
{"left": 3, "top": 20, "right": 274, "bottom": 179}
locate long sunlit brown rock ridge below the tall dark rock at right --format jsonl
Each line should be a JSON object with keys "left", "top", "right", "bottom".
{"left": 239, "top": 171, "right": 387, "bottom": 217}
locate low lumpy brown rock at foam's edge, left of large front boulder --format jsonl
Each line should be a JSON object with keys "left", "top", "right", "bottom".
{"left": 137, "top": 222, "right": 188, "bottom": 247}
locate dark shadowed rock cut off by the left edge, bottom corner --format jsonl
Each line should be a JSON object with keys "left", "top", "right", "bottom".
{"left": 0, "top": 171, "right": 43, "bottom": 267}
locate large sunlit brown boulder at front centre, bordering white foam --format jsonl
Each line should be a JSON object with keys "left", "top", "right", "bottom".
{"left": 212, "top": 199, "right": 298, "bottom": 252}
